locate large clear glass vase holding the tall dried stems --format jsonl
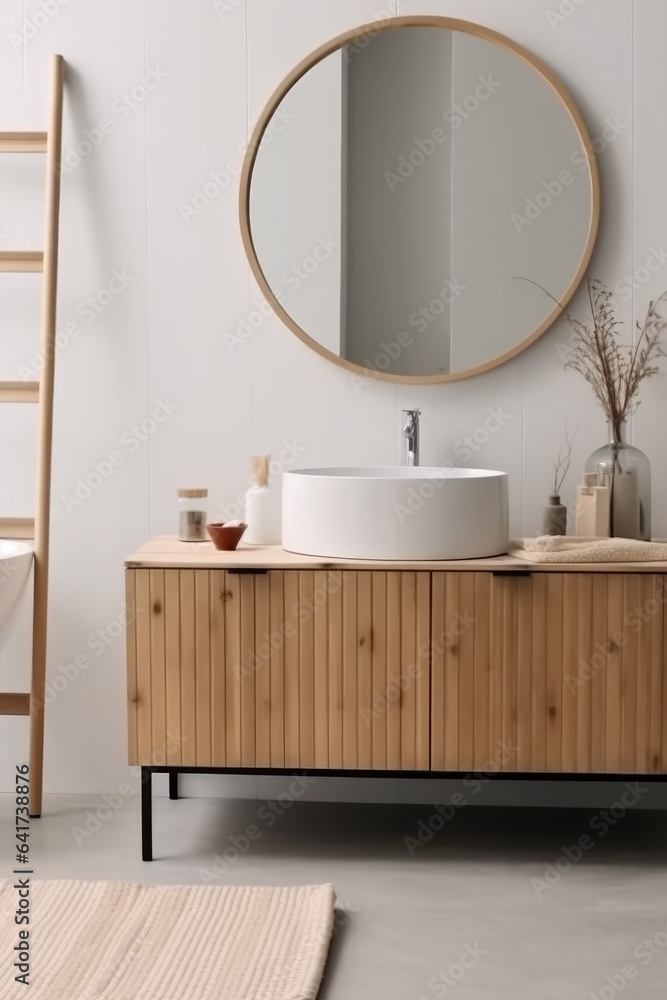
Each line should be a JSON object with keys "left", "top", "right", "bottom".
{"left": 585, "top": 421, "right": 651, "bottom": 541}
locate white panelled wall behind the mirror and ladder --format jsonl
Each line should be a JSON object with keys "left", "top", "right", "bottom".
{"left": 0, "top": 0, "right": 667, "bottom": 801}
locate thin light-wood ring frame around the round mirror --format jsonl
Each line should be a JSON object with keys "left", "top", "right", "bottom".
{"left": 239, "top": 16, "right": 600, "bottom": 385}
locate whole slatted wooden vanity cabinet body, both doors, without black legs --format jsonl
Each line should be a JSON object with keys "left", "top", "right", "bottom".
{"left": 126, "top": 543, "right": 667, "bottom": 774}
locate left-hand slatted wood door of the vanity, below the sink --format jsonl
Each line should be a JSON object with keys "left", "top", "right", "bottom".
{"left": 126, "top": 568, "right": 430, "bottom": 770}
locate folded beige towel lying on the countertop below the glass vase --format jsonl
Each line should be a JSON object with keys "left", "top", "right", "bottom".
{"left": 510, "top": 535, "right": 667, "bottom": 563}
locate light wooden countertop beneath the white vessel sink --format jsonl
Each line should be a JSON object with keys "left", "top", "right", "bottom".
{"left": 125, "top": 535, "right": 667, "bottom": 573}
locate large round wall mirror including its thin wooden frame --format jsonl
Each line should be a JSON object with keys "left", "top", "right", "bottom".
{"left": 241, "top": 17, "right": 599, "bottom": 382}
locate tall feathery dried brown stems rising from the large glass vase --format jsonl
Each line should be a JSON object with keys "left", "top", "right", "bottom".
{"left": 565, "top": 279, "right": 667, "bottom": 441}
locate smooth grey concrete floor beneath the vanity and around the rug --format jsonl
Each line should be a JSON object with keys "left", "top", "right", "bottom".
{"left": 0, "top": 792, "right": 667, "bottom": 1000}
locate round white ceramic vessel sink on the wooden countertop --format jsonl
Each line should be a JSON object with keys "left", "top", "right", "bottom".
{"left": 283, "top": 466, "right": 509, "bottom": 560}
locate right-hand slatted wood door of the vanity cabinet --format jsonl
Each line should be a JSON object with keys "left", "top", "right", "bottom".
{"left": 431, "top": 572, "right": 667, "bottom": 774}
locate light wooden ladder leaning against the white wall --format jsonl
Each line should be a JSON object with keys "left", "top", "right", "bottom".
{"left": 0, "top": 56, "right": 65, "bottom": 816}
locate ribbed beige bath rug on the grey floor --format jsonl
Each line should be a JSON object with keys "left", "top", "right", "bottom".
{"left": 0, "top": 881, "right": 335, "bottom": 1000}
